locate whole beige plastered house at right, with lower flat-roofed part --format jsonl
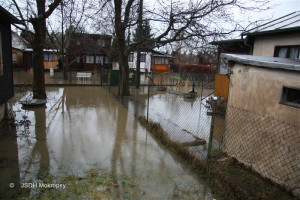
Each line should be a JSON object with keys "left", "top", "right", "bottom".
{"left": 215, "top": 12, "right": 300, "bottom": 198}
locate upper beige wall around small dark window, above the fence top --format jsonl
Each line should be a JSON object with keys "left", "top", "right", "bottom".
{"left": 228, "top": 64, "right": 300, "bottom": 126}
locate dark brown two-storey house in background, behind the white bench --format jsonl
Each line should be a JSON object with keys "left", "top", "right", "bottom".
{"left": 67, "top": 33, "right": 112, "bottom": 71}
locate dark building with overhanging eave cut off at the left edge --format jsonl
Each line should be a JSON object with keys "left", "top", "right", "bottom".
{"left": 0, "top": 6, "right": 21, "bottom": 120}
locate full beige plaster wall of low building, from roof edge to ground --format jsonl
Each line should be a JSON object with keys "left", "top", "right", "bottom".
{"left": 224, "top": 64, "right": 300, "bottom": 193}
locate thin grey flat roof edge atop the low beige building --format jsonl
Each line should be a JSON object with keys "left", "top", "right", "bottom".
{"left": 221, "top": 54, "right": 300, "bottom": 72}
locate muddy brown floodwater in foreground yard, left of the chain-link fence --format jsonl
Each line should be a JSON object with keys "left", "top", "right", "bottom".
{"left": 0, "top": 86, "right": 213, "bottom": 199}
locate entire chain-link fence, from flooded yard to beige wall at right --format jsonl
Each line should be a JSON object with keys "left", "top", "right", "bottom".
{"left": 107, "top": 70, "right": 300, "bottom": 195}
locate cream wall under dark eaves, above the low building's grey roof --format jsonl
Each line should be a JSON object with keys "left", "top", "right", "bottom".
{"left": 253, "top": 33, "right": 300, "bottom": 57}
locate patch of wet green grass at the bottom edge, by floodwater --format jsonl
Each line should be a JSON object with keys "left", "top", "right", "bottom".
{"left": 14, "top": 169, "right": 143, "bottom": 199}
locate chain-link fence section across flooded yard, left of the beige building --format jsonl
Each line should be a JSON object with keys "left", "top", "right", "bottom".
{"left": 105, "top": 73, "right": 220, "bottom": 163}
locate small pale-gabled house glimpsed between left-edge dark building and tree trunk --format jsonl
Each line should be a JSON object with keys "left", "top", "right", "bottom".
{"left": 11, "top": 31, "right": 28, "bottom": 68}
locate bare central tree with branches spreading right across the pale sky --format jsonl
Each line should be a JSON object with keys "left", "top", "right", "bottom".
{"left": 114, "top": 0, "right": 267, "bottom": 96}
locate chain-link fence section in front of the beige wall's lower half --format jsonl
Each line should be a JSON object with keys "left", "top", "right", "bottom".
{"left": 223, "top": 106, "right": 300, "bottom": 193}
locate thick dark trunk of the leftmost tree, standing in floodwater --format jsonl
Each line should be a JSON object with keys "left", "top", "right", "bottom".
{"left": 32, "top": 19, "right": 47, "bottom": 99}
